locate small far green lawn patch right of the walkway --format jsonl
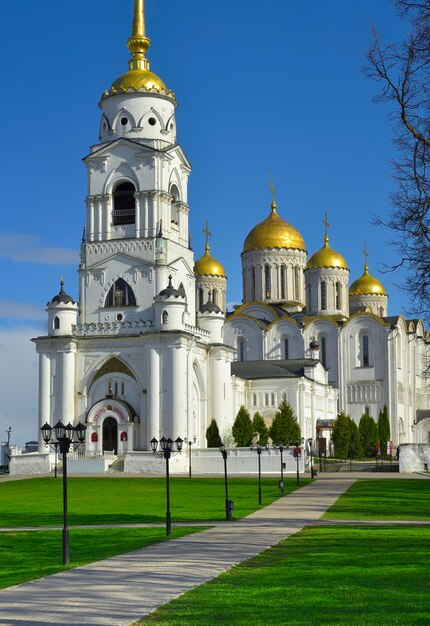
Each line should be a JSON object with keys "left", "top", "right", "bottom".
{"left": 323, "top": 479, "right": 430, "bottom": 521}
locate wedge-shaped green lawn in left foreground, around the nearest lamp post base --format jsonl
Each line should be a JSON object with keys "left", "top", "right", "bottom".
{"left": 0, "top": 526, "right": 201, "bottom": 589}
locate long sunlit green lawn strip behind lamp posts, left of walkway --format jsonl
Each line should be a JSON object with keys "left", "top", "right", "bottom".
{"left": 0, "top": 477, "right": 310, "bottom": 527}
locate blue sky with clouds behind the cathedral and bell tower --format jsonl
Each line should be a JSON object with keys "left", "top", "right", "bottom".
{"left": 0, "top": 0, "right": 408, "bottom": 444}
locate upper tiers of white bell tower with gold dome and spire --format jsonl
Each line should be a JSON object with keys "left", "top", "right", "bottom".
{"left": 80, "top": 0, "right": 195, "bottom": 325}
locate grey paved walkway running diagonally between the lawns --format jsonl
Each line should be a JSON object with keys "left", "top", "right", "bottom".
{"left": 0, "top": 474, "right": 424, "bottom": 626}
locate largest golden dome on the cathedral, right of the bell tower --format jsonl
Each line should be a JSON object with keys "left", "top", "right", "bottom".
{"left": 243, "top": 201, "right": 306, "bottom": 252}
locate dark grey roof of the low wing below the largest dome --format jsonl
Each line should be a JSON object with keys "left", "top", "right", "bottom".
{"left": 231, "top": 359, "right": 319, "bottom": 380}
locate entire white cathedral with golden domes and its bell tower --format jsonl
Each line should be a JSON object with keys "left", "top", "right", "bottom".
{"left": 34, "top": 0, "right": 430, "bottom": 455}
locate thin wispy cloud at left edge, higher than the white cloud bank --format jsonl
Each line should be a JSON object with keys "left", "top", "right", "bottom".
{"left": 0, "top": 234, "right": 78, "bottom": 265}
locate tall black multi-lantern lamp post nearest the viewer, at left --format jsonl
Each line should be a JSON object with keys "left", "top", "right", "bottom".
{"left": 40, "top": 421, "right": 87, "bottom": 565}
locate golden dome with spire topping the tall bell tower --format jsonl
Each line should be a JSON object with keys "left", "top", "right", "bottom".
{"left": 102, "top": 0, "right": 175, "bottom": 99}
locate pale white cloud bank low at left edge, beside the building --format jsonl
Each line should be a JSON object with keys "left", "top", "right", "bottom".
{"left": 0, "top": 325, "right": 40, "bottom": 445}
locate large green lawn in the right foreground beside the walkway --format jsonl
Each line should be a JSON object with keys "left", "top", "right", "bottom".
{"left": 138, "top": 524, "right": 430, "bottom": 626}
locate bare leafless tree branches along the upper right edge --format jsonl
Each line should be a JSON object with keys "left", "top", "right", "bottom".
{"left": 365, "top": 0, "right": 430, "bottom": 319}
